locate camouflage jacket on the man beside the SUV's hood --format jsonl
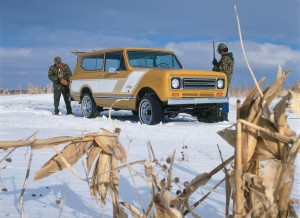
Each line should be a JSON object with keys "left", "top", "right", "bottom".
{"left": 213, "top": 52, "right": 234, "bottom": 88}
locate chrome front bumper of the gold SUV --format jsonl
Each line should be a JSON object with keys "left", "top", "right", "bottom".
{"left": 168, "top": 97, "right": 229, "bottom": 105}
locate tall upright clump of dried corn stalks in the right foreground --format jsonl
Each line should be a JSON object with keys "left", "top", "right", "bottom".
{"left": 219, "top": 68, "right": 300, "bottom": 217}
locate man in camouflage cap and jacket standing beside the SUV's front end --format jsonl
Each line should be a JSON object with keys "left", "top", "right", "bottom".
{"left": 212, "top": 43, "right": 234, "bottom": 121}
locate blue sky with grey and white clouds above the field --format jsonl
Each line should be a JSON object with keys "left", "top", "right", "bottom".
{"left": 0, "top": 0, "right": 300, "bottom": 89}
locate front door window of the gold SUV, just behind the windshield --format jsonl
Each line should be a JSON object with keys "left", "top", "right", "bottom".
{"left": 104, "top": 52, "right": 126, "bottom": 72}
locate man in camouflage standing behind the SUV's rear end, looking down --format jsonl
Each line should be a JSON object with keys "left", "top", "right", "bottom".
{"left": 48, "top": 57, "right": 73, "bottom": 115}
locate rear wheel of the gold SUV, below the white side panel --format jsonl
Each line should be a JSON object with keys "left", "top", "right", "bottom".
{"left": 81, "top": 93, "right": 99, "bottom": 118}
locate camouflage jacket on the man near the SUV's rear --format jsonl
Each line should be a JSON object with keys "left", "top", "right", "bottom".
{"left": 48, "top": 63, "right": 72, "bottom": 88}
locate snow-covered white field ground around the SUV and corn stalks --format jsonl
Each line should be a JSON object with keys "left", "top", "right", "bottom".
{"left": 0, "top": 94, "right": 300, "bottom": 218}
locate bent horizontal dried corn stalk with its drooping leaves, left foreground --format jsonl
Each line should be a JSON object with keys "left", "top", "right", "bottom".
{"left": 0, "top": 129, "right": 127, "bottom": 217}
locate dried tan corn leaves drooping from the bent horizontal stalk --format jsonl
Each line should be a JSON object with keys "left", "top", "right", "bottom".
{"left": 34, "top": 129, "right": 126, "bottom": 211}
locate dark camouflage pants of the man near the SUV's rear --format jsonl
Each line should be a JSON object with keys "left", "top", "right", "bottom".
{"left": 53, "top": 85, "right": 72, "bottom": 114}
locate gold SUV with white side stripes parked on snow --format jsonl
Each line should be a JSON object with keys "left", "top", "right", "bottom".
{"left": 71, "top": 48, "right": 228, "bottom": 125}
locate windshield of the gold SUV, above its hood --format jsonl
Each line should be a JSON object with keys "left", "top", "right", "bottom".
{"left": 127, "top": 51, "right": 182, "bottom": 69}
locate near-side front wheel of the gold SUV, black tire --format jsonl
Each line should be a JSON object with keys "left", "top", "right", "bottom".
{"left": 138, "top": 94, "right": 163, "bottom": 125}
